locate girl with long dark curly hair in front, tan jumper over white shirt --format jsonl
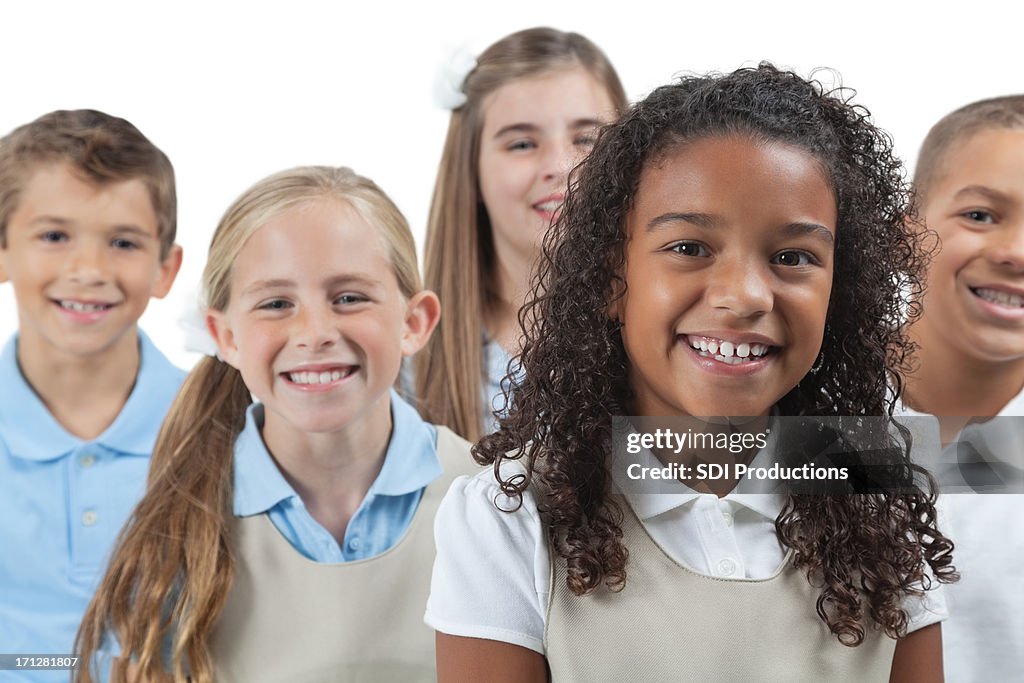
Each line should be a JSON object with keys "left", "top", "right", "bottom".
{"left": 427, "top": 65, "right": 955, "bottom": 681}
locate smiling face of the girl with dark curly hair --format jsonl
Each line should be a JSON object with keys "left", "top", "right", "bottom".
{"left": 611, "top": 137, "right": 837, "bottom": 417}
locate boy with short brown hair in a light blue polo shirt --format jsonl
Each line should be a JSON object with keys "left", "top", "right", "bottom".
{"left": 0, "top": 111, "right": 184, "bottom": 681}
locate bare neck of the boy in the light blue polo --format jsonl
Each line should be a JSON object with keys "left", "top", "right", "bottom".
{"left": 17, "top": 329, "right": 140, "bottom": 440}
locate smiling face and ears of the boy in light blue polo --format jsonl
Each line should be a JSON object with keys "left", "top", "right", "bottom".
{"left": 0, "top": 164, "right": 181, "bottom": 362}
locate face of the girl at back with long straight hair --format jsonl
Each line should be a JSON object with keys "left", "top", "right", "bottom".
{"left": 478, "top": 66, "right": 614, "bottom": 270}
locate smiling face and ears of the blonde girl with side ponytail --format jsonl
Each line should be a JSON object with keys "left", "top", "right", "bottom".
{"left": 207, "top": 199, "right": 436, "bottom": 450}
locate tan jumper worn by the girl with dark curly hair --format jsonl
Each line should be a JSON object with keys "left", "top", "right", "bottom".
{"left": 545, "top": 498, "right": 896, "bottom": 683}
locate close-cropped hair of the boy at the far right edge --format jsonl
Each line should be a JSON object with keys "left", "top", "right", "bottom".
{"left": 913, "top": 94, "right": 1024, "bottom": 202}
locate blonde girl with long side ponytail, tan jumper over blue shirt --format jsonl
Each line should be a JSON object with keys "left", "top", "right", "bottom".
{"left": 79, "top": 167, "right": 469, "bottom": 683}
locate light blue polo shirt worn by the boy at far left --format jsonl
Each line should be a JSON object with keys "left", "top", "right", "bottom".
{"left": 0, "top": 332, "right": 184, "bottom": 681}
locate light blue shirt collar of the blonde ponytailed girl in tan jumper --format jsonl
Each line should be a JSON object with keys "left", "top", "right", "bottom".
{"left": 233, "top": 390, "right": 441, "bottom": 517}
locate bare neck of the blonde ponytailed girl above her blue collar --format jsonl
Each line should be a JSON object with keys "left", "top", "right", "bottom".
{"left": 262, "top": 393, "right": 392, "bottom": 545}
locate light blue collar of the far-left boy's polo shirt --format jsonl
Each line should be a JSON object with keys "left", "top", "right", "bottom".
{"left": 0, "top": 330, "right": 184, "bottom": 461}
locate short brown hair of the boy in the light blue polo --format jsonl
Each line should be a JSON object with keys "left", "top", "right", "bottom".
{"left": 0, "top": 110, "right": 177, "bottom": 258}
